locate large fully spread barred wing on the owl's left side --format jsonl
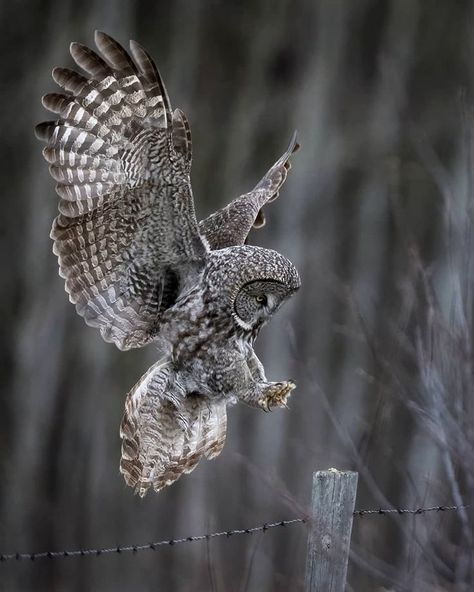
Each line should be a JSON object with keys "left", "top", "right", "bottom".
{"left": 36, "top": 32, "right": 208, "bottom": 349}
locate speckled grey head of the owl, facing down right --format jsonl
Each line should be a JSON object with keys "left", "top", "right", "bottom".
{"left": 206, "top": 245, "right": 301, "bottom": 333}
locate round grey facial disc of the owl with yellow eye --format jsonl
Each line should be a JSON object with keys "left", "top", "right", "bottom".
{"left": 234, "top": 280, "right": 295, "bottom": 331}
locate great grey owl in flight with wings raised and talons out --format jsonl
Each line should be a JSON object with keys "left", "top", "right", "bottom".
{"left": 36, "top": 32, "right": 300, "bottom": 496}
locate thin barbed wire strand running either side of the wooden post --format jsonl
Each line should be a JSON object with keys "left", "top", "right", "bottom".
{"left": 0, "top": 504, "right": 470, "bottom": 563}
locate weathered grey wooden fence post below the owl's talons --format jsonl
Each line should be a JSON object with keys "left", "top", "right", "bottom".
{"left": 305, "top": 469, "right": 358, "bottom": 592}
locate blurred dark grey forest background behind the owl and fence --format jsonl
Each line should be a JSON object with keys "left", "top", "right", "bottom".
{"left": 0, "top": 0, "right": 474, "bottom": 592}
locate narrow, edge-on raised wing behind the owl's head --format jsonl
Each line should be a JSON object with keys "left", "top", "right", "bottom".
{"left": 199, "top": 132, "right": 299, "bottom": 250}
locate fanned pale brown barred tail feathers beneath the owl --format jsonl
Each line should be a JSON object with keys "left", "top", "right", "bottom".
{"left": 120, "top": 360, "right": 227, "bottom": 497}
